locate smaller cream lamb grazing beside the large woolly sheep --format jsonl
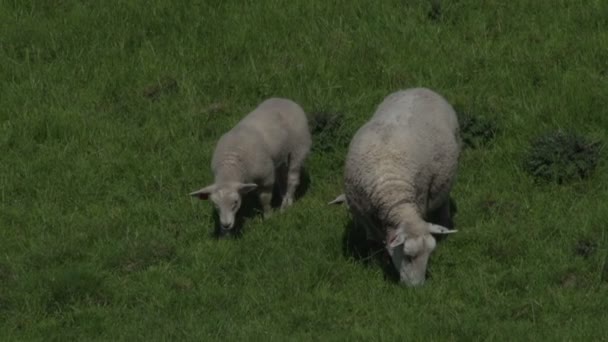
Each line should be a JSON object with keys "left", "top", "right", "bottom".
{"left": 190, "top": 98, "right": 312, "bottom": 232}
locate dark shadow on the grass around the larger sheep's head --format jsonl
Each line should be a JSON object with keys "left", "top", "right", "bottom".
{"left": 342, "top": 197, "right": 457, "bottom": 283}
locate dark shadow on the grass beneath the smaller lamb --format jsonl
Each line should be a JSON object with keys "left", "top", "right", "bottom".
{"left": 210, "top": 167, "right": 310, "bottom": 239}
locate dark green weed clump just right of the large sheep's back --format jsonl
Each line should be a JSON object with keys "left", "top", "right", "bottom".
{"left": 458, "top": 112, "right": 498, "bottom": 148}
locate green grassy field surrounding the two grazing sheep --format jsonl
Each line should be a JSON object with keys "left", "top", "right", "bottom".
{"left": 0, "top": 0, "right": 608, "bottom": 341}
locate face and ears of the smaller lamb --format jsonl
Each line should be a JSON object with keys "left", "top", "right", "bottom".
{"left": 190, "top": 183, "right": 257, "bottom": 230}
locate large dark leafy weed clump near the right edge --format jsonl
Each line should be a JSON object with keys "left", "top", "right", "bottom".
{"left": 523, "top": 131, "right": 601, "bottom": 184}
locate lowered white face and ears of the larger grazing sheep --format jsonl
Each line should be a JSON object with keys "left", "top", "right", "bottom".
{"left": 387, "top": 224, "right": 456, "bottom": 286}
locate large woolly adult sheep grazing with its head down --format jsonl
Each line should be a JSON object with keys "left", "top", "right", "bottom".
{"left": 329, "top": 88, "right": 462, "bottom": 286}
